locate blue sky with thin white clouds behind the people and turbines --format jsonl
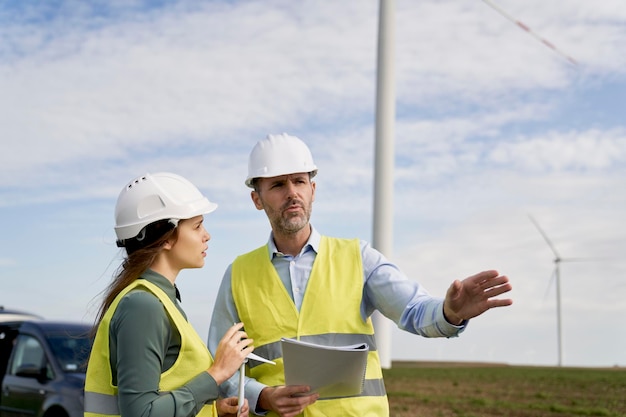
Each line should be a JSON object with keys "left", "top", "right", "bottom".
{"left": 0, "top": 0, "right": 626, "bottom": 366}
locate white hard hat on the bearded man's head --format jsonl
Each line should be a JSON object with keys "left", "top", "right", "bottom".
{"left": 246, "top": 133, "right": 317, "bottom": 188}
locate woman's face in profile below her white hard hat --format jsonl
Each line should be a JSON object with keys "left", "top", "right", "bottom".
{"left": 169, "top": 216, "right": 211, "bottom": 270}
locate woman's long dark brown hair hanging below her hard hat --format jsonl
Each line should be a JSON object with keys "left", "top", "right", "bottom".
{"left": 93, "top": 220, "right": 178, "bottom": 332}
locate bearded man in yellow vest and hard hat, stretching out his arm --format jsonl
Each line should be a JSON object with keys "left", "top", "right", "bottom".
{"left": 208, "top": 134, "right": 512, "bottom": 417}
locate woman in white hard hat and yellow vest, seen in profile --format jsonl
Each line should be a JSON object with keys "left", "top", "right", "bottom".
{"left": 85, "top": 173, "right": 253, "bottom": 417}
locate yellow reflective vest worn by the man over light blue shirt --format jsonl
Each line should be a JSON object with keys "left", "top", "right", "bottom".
{"left": 232, "top": 236, "right": 389, "bottom": 417}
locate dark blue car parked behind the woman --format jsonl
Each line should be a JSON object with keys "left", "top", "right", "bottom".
{"left": 0, "top": 314, "right": 92, "bottom": 417}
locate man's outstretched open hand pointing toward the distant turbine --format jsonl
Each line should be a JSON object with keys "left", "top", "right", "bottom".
{"left": 443, "top": 270, "right": 513, "bottom": 325}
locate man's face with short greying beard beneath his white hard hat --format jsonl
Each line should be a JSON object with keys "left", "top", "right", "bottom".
{"left": 251, "top": 172, "right": 315, "bottom": 235}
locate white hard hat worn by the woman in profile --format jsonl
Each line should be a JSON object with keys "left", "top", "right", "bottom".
{"left": 115, "top": 172, "right": 217, "bottom": 241}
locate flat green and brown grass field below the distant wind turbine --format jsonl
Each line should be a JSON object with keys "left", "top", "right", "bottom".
{"left": 383, "top": 362, "right": 626, "bottom": 417}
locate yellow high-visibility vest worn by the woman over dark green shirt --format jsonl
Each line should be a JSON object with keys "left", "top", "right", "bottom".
{"left": 84, "top": 279, "right": 217, "bottom": 417}
